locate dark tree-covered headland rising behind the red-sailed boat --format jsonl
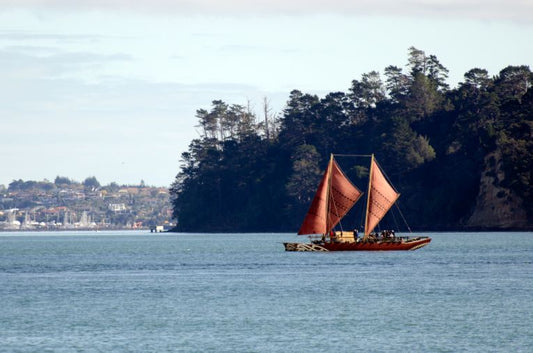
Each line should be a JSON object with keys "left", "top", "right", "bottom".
{"left": 171, "top": 47, "right": 533, "bottom": 232}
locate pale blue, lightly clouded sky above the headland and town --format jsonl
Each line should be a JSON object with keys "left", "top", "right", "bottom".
{"left": 0, "top": 0, "right": 533, "bottom": 187}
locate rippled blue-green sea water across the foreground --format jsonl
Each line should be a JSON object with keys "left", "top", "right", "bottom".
{"left": 0, "top": 232, "right": 533, "bottom": 353}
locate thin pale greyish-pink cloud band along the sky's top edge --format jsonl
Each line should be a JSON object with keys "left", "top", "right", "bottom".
{"left": 0, "top": 0, "right": 533, "bottom": 23}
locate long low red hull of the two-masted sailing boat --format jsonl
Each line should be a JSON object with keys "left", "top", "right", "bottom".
{"left": 283, "top": 237, "right": 431, "bottom": 251}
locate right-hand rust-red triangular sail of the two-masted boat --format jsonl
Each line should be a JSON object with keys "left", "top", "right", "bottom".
{"left": 365, "top": 158, "right": 400, "bottom": 236}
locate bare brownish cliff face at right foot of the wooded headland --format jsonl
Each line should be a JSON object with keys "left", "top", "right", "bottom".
{"left": 466, "top": 150, "right": 529, "bottom": 229}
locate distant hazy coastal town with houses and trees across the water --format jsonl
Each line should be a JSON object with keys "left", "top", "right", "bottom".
{"left": 0, "top": 176, "right": 175, "bottom": 232}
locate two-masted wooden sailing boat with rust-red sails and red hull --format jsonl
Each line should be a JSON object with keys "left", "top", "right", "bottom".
{"left": 283, "top": 154, "right": 431, "bottom": 251}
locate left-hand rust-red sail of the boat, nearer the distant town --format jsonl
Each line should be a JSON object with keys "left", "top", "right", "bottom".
{"left": 298, "top": 158, "right": 362, "bottom": 234}
